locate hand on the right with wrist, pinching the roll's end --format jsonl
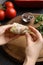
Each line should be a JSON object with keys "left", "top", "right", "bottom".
{"left": 23, "top": 26, "right": 43, "bottom": 65}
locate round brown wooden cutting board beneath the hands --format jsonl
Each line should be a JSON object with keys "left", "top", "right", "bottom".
{"left": 3, "top": 14, "right": 43, "bottom": 62}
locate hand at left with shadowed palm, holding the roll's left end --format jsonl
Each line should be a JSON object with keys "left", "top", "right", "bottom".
{"left": 0, "top": 24, "right": 19, "bottom": 45}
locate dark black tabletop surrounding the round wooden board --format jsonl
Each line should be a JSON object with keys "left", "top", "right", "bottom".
{"left": 0, "top": 0, "right": 43, "bottom": 65}
